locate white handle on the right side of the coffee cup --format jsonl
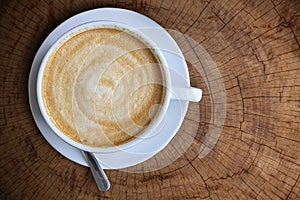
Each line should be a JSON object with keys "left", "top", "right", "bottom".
{"left": 171, "top": 87, "right": 202, "bottom": 102}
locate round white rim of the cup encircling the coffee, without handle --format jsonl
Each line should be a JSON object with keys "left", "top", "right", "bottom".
{"left": 36, "top": 20, "right": 171, "bottom": 153}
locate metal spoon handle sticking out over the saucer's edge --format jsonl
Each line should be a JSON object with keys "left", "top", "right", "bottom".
{"left": 82, "top": 151, "right": 110, "bottom": 191}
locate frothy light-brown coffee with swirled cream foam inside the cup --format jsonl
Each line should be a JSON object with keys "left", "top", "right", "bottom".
{"left": 42, "top": 27, "right": 166, "bottom": 147}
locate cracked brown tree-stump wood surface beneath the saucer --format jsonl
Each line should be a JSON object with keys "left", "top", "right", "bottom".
{"left": 0, "top": 0, "right": 300, "bottom": 199}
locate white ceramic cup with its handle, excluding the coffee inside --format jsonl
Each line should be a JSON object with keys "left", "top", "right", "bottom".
{"left": 37, "top": 21, "right": 202, "bottom": 153}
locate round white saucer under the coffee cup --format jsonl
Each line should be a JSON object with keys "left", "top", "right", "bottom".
{"left": 28, "top": 8, "right": 190, "bottom": 169}
